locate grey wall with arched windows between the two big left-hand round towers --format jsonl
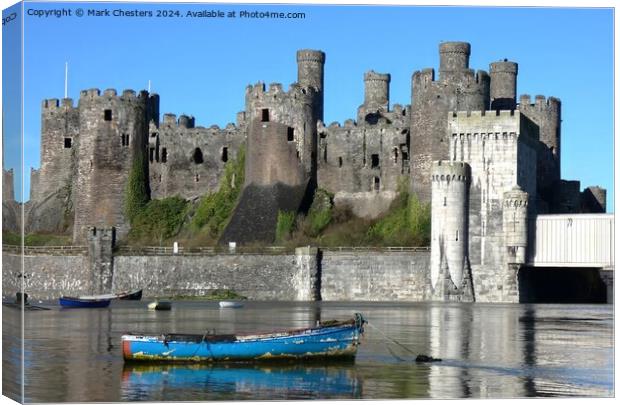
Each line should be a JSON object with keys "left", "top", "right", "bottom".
{"left": 148, "top": 114, "right": 245, "bottom": 200}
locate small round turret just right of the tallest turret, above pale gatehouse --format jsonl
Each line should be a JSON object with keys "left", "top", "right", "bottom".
{"left": 489, "top": 59, "right": 519, "bottom": 110}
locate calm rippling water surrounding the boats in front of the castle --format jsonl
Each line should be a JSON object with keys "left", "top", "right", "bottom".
{"left": 2, "top": 300, "right": 614, "bottom": 402}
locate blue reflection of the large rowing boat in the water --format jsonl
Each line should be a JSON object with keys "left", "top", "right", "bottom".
{"left": 121, "top": 364, "right": 362, "bottom": 401}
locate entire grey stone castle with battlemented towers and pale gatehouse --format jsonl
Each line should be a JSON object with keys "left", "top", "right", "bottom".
{"left": 3, "top": 42, "right": 606, "bottom": 301}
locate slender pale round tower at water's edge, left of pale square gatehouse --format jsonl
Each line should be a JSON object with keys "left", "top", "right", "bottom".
{"left": 431, "top": 160, "right": 473, "bottom": 301}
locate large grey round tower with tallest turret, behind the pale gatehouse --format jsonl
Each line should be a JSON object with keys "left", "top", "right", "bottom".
{"left": 410, "top": 42, "right": 490, "bottom": 202}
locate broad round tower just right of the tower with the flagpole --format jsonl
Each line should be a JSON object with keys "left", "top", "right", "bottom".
{"left": 73, "top": 89, "right": 158, "bottom": 243}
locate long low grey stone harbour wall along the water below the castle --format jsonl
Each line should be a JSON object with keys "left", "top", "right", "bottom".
{"left": 2, "top": 247, "right": 430, "bottom": 301}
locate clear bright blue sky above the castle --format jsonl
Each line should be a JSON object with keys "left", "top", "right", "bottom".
{"left": 5, "top": 3, "right": 614, "bottom": 211}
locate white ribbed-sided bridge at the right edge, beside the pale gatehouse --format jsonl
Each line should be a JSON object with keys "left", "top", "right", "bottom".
{"left": 526, "top": 214, "right": 615, "bottom": 302}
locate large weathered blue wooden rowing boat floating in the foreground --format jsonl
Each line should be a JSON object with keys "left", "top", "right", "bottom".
{"left": 121, "top": 314, "right": 366, "bottom": 362}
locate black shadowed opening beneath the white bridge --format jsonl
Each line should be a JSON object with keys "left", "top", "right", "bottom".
{"left": 519, "top": 267, "right": 607, "bottom": 304}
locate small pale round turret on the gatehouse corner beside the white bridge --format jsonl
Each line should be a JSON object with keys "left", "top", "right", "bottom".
{"left": 502, "top": 186, "right": 529, "bottom": 264}
